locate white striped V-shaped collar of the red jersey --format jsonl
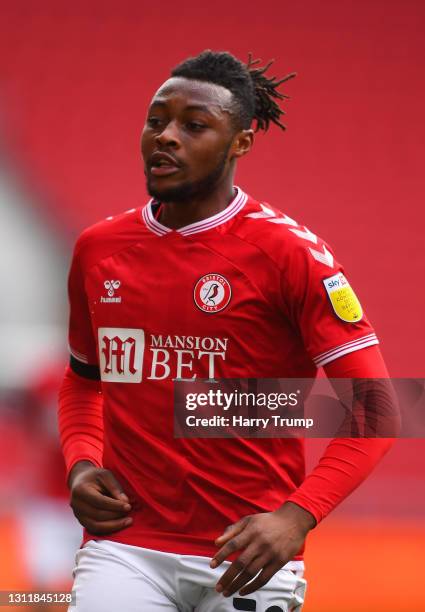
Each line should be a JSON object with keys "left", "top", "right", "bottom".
{"left": 142, "top": 187, "right": 248, "bottom": 236}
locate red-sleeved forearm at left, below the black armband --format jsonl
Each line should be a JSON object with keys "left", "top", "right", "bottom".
{"left": 58, "top": 368, "right": 103, "bottom": 480}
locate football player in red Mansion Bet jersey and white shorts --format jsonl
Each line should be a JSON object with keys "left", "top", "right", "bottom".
{"left": 59, "top": 51, "right": 390, "bottom": 612}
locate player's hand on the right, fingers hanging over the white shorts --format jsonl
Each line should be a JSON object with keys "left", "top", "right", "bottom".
{"left": 210, "top": 502, "right": 316, "bottom": 597}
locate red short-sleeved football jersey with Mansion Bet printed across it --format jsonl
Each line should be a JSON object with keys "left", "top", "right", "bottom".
{"left": 69, "top": 188, "right": 378, "bottom": 558}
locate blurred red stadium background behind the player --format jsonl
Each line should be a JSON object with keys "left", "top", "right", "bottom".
{"left": 0, "top": 0, "right": 425, "bottom": 612}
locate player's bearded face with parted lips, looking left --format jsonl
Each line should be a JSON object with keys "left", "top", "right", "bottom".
{"left": 142, "top": 77, "right": 252, "bottom": 202}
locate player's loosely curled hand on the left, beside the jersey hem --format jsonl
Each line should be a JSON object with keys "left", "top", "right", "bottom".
{"left": 69, "top": 461, "right": 133, "bottom": 535}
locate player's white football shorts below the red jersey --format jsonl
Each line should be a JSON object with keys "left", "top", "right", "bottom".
{"left": 68, "top": 540, "right": 306, "bottom": 612}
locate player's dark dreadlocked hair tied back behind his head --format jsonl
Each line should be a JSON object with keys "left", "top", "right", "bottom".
{"left": 171, "top": 49, "right": 296, "bottom": 132}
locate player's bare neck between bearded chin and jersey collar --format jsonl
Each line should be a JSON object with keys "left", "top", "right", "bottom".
{"left": 158, "top": 177, "right": 235, "bottom": 229}
